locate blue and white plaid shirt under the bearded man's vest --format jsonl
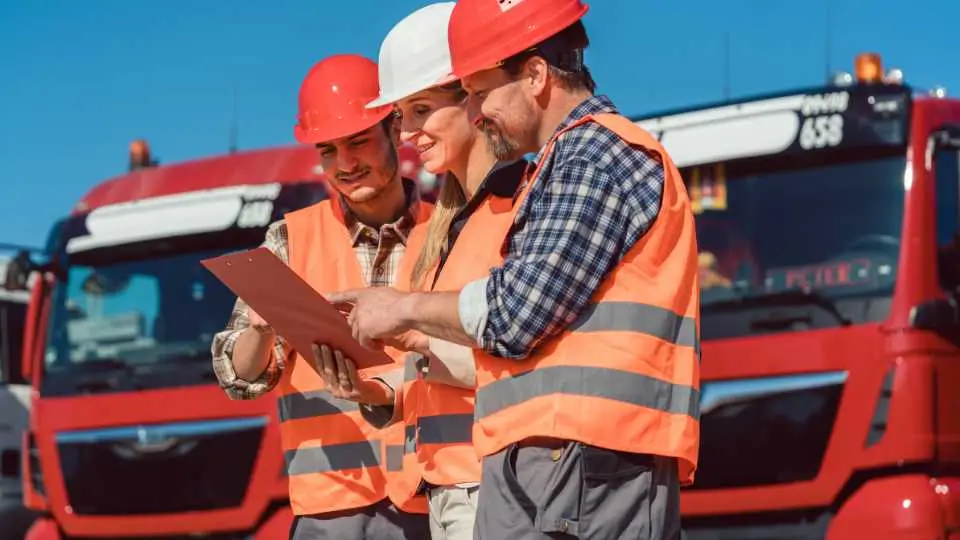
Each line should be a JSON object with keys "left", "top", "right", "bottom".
{"left": 460, "top": 96, "right": 664, "bottom": 359}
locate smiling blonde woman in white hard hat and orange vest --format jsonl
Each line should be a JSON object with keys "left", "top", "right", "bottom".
{"left": 364, "top": 2, "right": 526, "bottom": 540}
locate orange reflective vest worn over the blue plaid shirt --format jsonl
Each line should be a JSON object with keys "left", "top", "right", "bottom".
{"left": 468, "top": 114, "right": 700, "bottom": 484}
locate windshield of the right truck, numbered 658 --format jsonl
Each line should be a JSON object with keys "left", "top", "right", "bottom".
{"left": 682, "top": 149, "right": 906, "bottom": 339}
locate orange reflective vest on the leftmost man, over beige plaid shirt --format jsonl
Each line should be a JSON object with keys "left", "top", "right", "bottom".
{"left": 277, "top": 198, "right": 433, "bottom": 515}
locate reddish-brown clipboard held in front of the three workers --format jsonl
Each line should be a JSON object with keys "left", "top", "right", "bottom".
{"left": 200, "top": 247, "right": 394, "bottom": 369}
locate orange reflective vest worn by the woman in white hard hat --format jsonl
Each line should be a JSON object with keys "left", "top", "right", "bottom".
{"left": 388, "top": 186, "right": 513, "bottom": 506}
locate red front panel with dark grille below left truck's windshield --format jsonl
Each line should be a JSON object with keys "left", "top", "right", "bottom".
{"left": 33, "top": 386, "right": 287, "bottom": 536}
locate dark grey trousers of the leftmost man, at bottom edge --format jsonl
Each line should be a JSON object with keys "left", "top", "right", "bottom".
{"left": 290, "top": 499, "right": 430, "bottom": 540}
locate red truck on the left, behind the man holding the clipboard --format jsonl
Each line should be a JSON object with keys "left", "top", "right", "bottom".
{"left": 6, "top": 141, "right": 430, "bottom": 540}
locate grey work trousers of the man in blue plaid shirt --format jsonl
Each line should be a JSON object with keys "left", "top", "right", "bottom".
{"left": 474, "top": 441, "right": 680, "bottom": 540}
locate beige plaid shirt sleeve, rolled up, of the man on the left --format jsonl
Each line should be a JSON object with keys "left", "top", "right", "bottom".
{"left": 210, "top": 221, "right": 290, "bottom": 400}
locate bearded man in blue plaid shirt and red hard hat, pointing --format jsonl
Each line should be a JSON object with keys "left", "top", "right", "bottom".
{"left": 331, "top": 0, "right": 700, "bottom": 540}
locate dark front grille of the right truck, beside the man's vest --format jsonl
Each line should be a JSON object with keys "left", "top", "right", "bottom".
{"left": 687, "top": 372, "right": 847, "bottom": 490}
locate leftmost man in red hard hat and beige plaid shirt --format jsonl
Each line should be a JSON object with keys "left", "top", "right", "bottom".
{"left": 212, "top": 55, "right": 432, "bottom": 540}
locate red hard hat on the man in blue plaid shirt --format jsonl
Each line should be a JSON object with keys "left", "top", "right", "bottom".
{"left": 448, "top": 0, "right": 588, "bottom": 78}
